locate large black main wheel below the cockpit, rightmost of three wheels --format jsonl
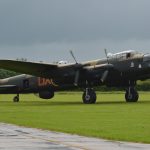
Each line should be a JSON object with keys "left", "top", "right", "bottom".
{"left": 125, "top": 88, "right": 139, "bottom": 102}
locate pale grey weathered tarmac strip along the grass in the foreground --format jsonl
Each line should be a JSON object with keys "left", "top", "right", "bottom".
{"left": 0, "top": 123, "right": 150, "bottom": 150}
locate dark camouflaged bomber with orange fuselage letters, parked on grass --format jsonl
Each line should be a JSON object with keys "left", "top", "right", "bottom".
{"left": 0, "top": 50, "right": 150, "bottom": 103}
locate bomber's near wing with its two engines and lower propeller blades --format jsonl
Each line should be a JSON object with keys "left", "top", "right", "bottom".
{"left": 0, "top": 60, "right": 114, "bottom": 84}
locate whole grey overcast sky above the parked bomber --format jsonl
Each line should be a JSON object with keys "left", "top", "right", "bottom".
{"left": 0, "top": 0, "right": 150, "bottom": 62}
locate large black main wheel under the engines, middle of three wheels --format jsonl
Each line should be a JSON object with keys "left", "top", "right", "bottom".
{"left": 82, "top": 88, "right": 96, "bottom": 104}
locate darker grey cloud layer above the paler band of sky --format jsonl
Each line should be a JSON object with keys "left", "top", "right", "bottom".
{"left": 0, "top": 0, "right": 150, "bottom": 45}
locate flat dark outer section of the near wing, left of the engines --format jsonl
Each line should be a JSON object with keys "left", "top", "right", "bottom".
{"left": 0, "top": 60, "right": 57, "bottom": 77}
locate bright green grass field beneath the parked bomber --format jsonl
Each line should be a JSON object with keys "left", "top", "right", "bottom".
{"left": 0, "top": 92, "right": 150, "bottom": 143}
